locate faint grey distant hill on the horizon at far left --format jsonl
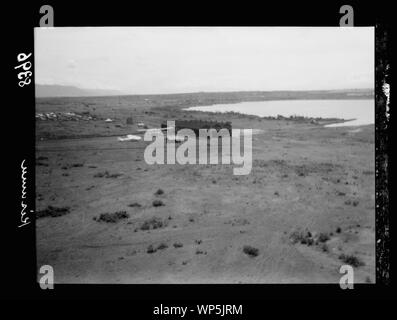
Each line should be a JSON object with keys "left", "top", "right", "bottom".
{"left": 36, "top": 84, "right": 123, "bottom": 98}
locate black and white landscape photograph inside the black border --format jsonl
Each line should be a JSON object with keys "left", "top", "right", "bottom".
{"left": 34, "top": 27, "right": 375, "bottom": 284}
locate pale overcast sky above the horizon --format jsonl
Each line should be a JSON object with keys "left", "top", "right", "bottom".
{"left": 35, "top": 27, "right": 374, "bottom": 94}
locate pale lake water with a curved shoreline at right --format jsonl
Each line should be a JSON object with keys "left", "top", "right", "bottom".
{"left": 186, "top": 99, "right": 375, "bottom": 127}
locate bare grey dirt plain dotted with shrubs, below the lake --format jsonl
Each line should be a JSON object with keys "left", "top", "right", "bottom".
{"left": 36, "top": 97, "right": 375, "bottom": 283}
